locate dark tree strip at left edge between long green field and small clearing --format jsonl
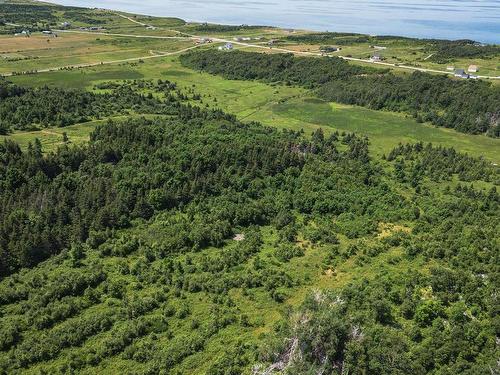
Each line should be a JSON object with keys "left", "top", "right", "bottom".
{"left": 0, "top": 80, "right": 182, "bottom": 134}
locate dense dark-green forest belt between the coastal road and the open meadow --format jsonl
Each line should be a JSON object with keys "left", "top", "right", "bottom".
{"left": 181, "top": 50, "right": 500, "bottom": 137}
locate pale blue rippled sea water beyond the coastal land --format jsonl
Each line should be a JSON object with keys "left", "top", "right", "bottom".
{"left": 46, "top": 0, "right": 500, "bottom": 44}
